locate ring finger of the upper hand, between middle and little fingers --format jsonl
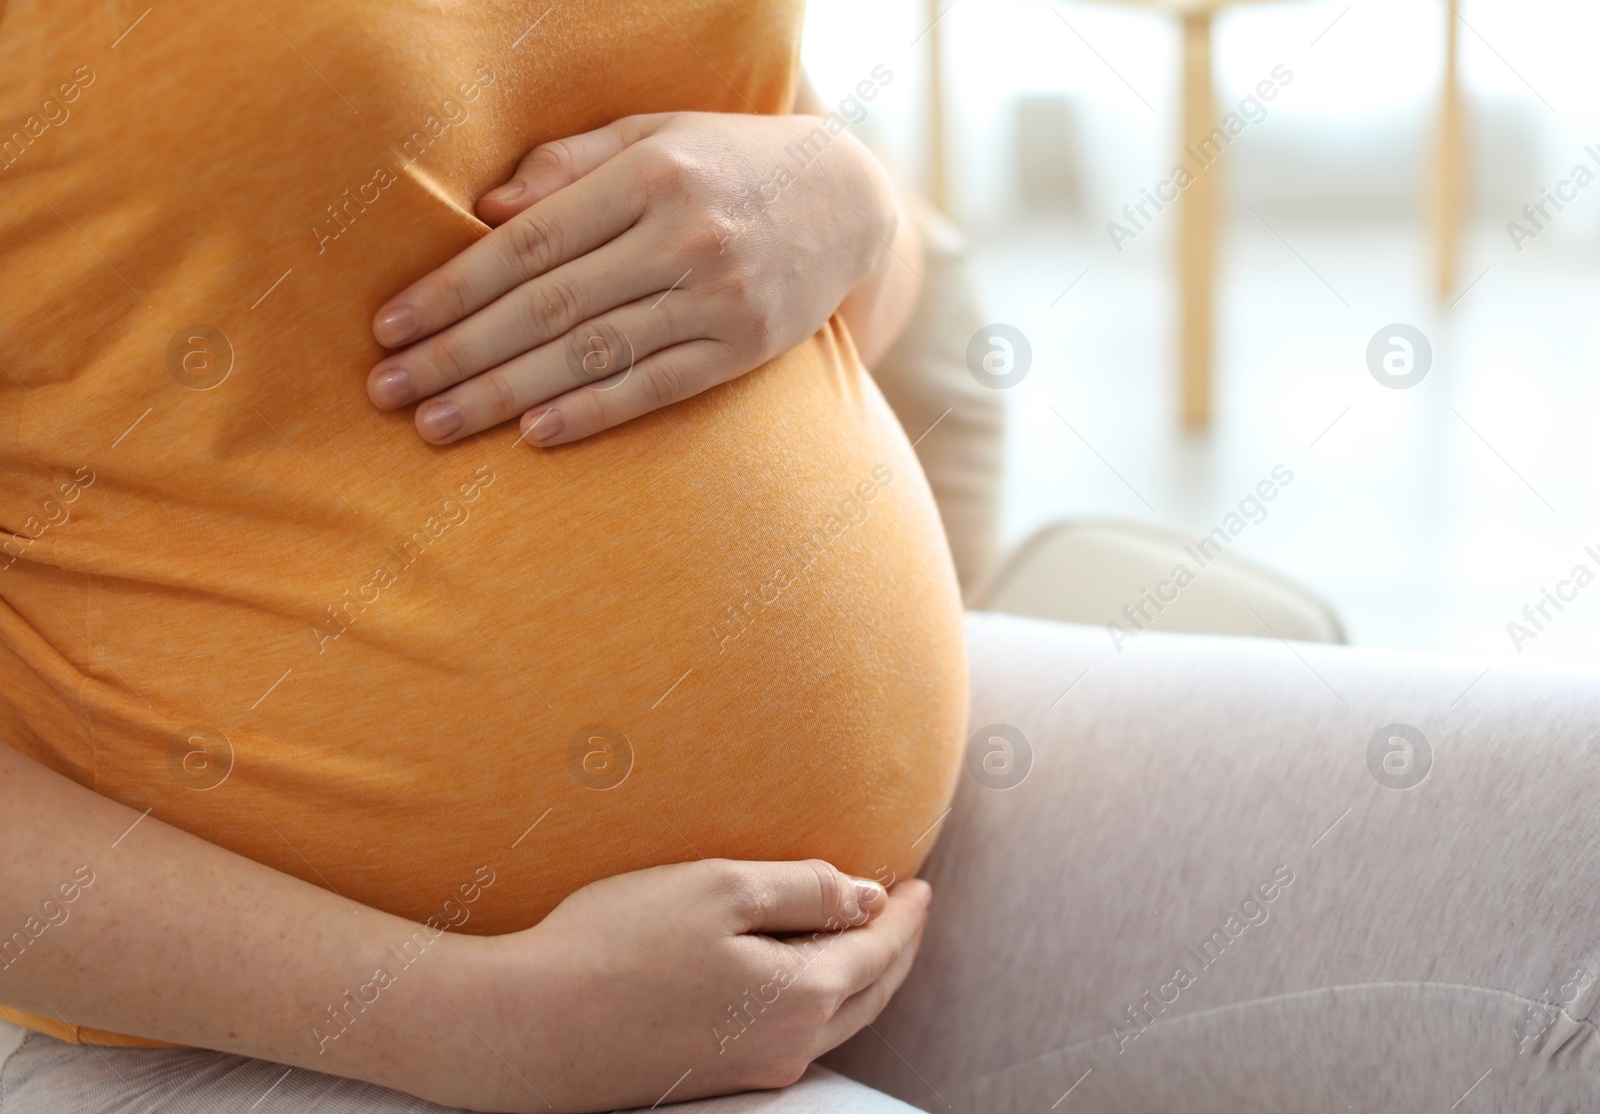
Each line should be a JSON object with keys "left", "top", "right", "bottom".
{"left": 416, "top": 299, "right": 706, "bottom": 445}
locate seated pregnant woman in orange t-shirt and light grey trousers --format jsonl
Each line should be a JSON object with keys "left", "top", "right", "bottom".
{"left": 9, "top": 0, "right": 1600, "bottom": 1114}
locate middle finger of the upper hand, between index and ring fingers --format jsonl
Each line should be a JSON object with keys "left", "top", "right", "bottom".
{"left": 366, "top": 232, "right": 672, "bottom": 418}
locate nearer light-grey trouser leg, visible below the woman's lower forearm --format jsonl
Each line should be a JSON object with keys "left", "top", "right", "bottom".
{"left": 0, "top": 1023, "right": 910, "bottom": 1114}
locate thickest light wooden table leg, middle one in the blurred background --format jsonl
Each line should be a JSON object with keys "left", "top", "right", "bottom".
{"left": 1178, "top": 13, "right": 1222, "bottom": 429}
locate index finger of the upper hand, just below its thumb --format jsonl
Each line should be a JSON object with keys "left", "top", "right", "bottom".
{"left": 373, "top": 158, "right": 645, "bottom": 347}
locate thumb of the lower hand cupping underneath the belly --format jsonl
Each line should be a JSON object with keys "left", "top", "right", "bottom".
{"left": 709, "top": 860, "right": 888, "bottom": 935}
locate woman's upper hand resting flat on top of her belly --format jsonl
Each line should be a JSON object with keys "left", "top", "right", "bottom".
{"left": 368, "top": 112, "right": 898, "bottom": 445}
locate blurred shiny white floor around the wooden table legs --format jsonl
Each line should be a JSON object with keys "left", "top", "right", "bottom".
{"left": 976, "top": 219, "right": 1600, "bottom": 661}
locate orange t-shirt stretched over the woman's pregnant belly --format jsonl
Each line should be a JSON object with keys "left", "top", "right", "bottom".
{"left": 0, "top": 0, "right": 966, "bottom": 1042}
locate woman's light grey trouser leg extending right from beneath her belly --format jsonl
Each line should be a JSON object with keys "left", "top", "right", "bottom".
{"left": 824, "top": 616, "right": 1600, "bottom": 1114}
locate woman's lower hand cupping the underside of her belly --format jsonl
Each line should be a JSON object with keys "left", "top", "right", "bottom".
{"left": 437, "top": 860, "right": 931, "bottom": 1111}
